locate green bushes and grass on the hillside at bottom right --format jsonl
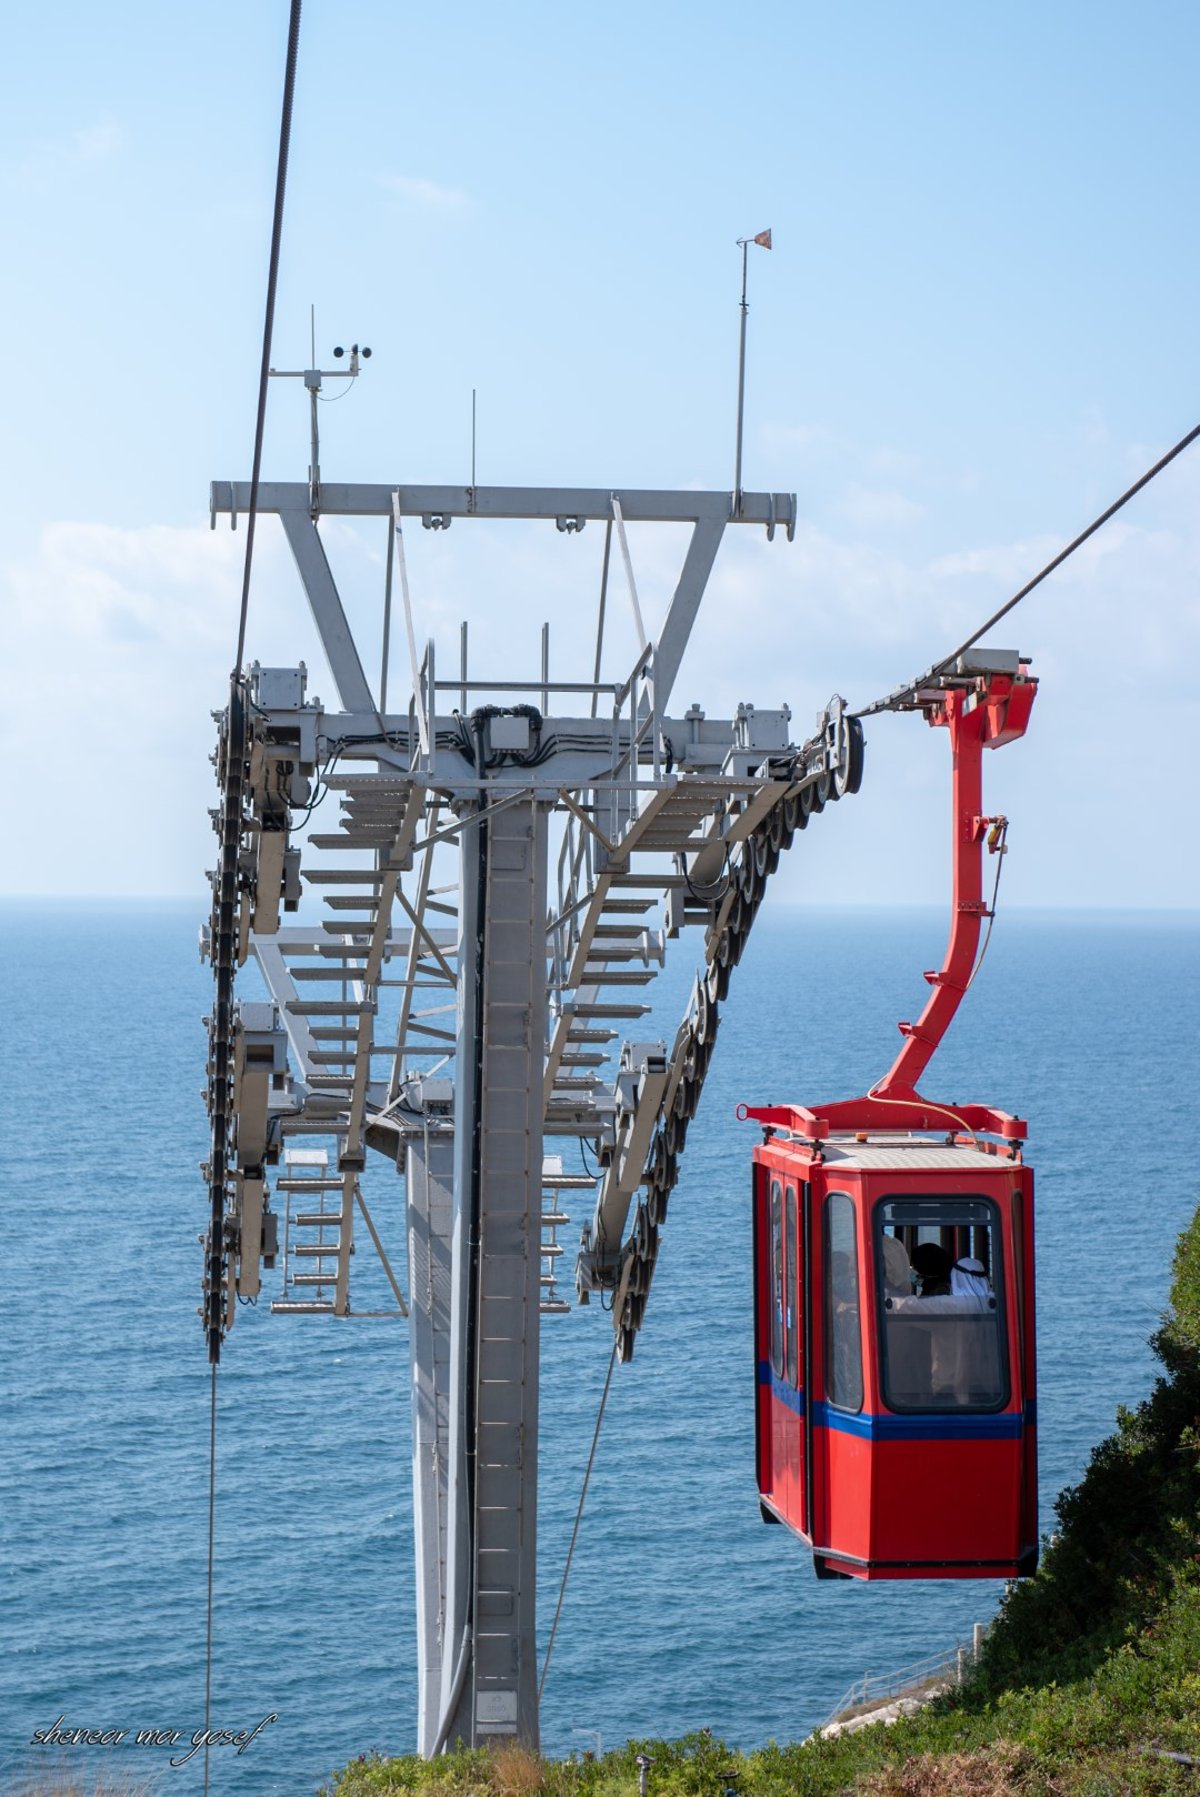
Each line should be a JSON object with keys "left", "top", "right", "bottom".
{"left": 323, "top": 1213, "right": 1200, "bottom": 1797}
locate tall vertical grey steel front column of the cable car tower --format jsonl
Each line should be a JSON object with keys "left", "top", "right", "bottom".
{"left": 438, "top": 803, "right": 548, "bottom": 1750}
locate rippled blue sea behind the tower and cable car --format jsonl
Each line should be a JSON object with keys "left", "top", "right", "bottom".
{"left": 0, "top": 902, "right": 1200, "bottom": 1797}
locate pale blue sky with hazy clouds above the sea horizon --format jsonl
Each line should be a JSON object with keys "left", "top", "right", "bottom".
{"left": 0, "top": 0, "right": 1200, "bottom": 898}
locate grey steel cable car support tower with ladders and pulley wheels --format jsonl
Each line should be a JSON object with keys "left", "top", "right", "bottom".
{"left": 207, "top": 476, "right": 862, "bottom": 1754}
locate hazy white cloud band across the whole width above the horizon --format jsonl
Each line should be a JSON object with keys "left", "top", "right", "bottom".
{"left": 0, "top": 471, "right": 1200, "bottom": 906}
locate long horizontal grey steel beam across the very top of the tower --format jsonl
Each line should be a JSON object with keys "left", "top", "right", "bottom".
{"left": 210, "top": 480, "right": 796, "bottom": 528}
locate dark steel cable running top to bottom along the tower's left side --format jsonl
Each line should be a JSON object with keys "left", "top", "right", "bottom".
{"left": 205, "top": 0, "right": 302, "bottom": 1797}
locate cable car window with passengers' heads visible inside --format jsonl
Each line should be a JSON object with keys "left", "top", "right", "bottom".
{"left": 875, "top": 1197, "right": 1008, "bottom": 1411}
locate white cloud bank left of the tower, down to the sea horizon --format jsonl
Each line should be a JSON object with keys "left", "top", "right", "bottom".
{"left": 0, "top": 523, "right": 323, "bottom": 895}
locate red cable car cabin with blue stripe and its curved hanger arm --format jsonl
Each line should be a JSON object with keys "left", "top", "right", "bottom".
{"left": 738, "top": 654, "right": 1038, "bottom": 1578}
